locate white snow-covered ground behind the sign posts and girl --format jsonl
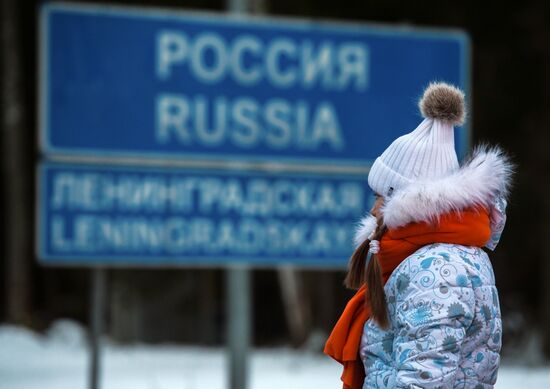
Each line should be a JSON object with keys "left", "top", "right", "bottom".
{"left": 0, "top": 321, "right": 550, "bottom": 389}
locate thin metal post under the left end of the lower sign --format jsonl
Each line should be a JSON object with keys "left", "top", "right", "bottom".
{"left": 88, "top": 267, "right": 106, "bottom": 389}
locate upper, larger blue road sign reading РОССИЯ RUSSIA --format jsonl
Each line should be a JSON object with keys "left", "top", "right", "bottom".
{"left": 40, "top": 4, "right": 469, "bottom": 167}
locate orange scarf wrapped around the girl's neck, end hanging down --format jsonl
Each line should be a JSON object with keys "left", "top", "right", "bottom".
{"left": 324, "top": 208, "right": 491, "bottom": 389}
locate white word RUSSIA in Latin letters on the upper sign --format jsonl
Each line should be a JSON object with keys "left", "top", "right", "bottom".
{"left": 156, "top": 94, "right": 344, "bottom": 151}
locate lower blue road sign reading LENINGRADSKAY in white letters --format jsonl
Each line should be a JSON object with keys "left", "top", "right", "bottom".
{"left": 37, "top": 163, "right": 370, "bottom": 266}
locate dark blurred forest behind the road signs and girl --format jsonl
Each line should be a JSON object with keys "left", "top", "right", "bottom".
{"left": 0, "top": 0, "right": 550, "bottom": 357}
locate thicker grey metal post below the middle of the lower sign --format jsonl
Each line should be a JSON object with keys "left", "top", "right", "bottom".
{"left": 226, "top": 265, "right": 251, "bottom": 389}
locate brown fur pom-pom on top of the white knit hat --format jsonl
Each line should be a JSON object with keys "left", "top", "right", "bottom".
{"left": 418, "top": 82, "right": 466, "bottom": 125}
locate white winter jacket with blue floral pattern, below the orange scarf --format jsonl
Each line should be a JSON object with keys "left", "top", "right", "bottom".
{"left": 360, "top": 243, "right": 502, "bottom": 389}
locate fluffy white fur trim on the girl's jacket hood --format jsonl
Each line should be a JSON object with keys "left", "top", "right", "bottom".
{"left": 355, "top": 145, "right": 514, "bottom": 245}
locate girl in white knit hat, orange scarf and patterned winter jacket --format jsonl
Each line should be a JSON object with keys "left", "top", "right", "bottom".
{"left": 325, "top": 83, "right": 512, "bottom": 389}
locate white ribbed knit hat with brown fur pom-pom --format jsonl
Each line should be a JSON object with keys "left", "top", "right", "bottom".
{"left": 368, "top": 83, "right": 466, "bottom": 196}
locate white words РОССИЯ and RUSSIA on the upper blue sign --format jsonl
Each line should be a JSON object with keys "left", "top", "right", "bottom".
{"left": 155, "top": 31, "right": 369, "bottom": 153}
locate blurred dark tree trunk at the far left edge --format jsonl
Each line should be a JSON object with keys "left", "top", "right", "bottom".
{"left": 1, "top": 0, "right": 33, "bottom": 324}
